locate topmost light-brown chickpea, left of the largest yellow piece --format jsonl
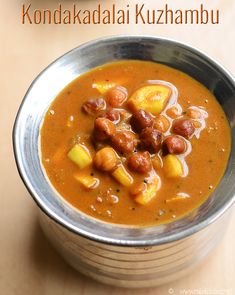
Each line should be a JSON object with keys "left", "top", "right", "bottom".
{"left": 106, "top": 86, "right": 128, "bottom": 108}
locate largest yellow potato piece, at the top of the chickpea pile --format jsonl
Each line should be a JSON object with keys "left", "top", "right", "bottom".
{"left": 128, "top": 85, "right": 171, "bottom": 115}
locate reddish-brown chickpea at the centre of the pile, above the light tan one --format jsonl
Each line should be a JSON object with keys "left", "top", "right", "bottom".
{"left": 111, "top": 131, "right": 137, "bottom": 154}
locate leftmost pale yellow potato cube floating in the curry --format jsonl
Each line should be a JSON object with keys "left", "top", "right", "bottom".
{"left": 68, "top": 144, "right": 92, "bottom": 169}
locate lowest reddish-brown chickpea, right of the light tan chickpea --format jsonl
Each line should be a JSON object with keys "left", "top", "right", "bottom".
{"left": 127, "top": 151, "right": 152, "bottom": 174}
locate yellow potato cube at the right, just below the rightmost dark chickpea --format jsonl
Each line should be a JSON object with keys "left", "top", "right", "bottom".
{"left": 163, "top": 155, "right": 184, "bottom": 178}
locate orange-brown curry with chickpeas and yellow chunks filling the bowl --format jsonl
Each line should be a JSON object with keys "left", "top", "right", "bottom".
{"left": 40, "top": 60, "right": 231, "bottom": 226}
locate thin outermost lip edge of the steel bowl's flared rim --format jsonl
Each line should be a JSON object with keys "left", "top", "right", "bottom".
{"left": 12, "top": 35, "right": 235, "bottom": 247}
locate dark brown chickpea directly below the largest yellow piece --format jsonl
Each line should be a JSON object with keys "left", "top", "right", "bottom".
{"left": 130, "top": 110, "right": 153, "bottom": 132}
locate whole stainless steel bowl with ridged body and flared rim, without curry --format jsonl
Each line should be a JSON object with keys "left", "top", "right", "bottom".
{"left": 13, "top": 36, "right": 235, "bottom": 287}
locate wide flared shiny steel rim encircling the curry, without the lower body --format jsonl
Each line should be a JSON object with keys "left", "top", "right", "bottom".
{"left": 13, "top": 36, "right": 235, "bottom": 246}
